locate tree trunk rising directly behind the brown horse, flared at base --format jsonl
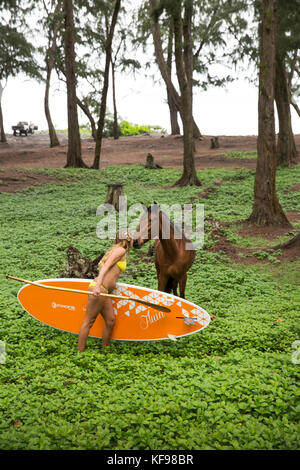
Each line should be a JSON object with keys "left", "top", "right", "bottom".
{"left": 173, "top": 0, "right": 201, "bottom": 186}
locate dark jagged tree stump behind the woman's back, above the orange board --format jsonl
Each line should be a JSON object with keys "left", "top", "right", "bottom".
{"left": 60, "top": 245, "right": 104, "bottom": 279}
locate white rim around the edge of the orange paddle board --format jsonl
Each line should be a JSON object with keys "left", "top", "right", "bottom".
{"left": 17, "top": 277, "right": 211, "bottom": 342}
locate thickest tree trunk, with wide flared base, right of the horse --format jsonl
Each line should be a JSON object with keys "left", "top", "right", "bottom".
{"left": 248, "top": 0, "right": 290, "bottom": 227}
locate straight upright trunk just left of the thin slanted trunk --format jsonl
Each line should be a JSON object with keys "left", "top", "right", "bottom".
{"left": 64, "top": 0, "right": 87, "bottom": 168}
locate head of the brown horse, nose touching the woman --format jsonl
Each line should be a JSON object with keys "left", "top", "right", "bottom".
{"left": 133, "top": 202, "right": 160, "bottom": 248}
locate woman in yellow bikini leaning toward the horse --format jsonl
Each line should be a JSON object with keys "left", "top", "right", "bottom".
{"left": 78, "top": 231, "right": 133, "bottom": 352}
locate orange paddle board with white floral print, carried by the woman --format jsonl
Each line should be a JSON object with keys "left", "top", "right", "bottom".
{"left": 18, "top": 279, "right": 210, "bottom": 341}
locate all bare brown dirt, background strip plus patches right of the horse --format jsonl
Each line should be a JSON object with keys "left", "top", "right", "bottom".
{"left": 0, "top": 133, "right": 300, "bottom": 264}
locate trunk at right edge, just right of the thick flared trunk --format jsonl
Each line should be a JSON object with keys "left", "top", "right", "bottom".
{"left": 275, "top": 53, "right": 297, "bottom": 166}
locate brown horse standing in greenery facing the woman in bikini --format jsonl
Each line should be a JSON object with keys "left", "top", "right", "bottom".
{"left": 133, "top": 203, "right": 196, "bottom": 298}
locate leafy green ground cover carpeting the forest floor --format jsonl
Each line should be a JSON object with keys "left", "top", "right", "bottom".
{"left": 0, "top": 165, "right": 300, "bottom": 450}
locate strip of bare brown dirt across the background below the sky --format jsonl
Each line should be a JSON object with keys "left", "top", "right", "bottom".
{"left": 0, "top": 133, "right": 300, "bottom": 192}
